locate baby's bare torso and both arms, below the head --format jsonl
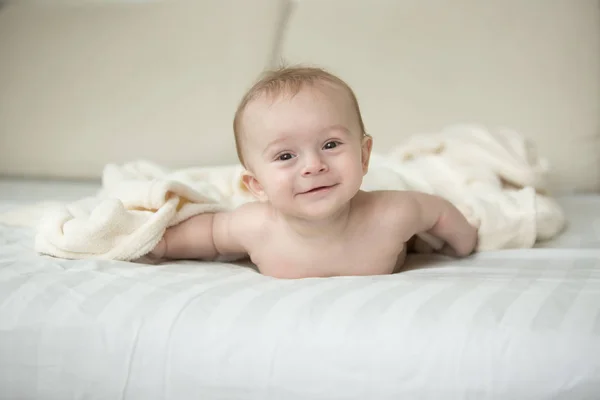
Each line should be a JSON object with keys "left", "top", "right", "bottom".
{"left": 154, "top": 191, "right": 477, "bottom": 279}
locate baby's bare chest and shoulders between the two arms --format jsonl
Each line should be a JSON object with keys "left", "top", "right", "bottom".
{"left": 249, "top": 192, "right": 406, "bottom": 277}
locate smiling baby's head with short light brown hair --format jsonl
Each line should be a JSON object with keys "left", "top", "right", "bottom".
{"left": 233, "top": 67, "right": 372, "bottom": 218}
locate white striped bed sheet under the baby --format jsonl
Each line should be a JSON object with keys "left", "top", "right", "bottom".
{"left": 0, "top": 181, "right": 600, "bottom": 400}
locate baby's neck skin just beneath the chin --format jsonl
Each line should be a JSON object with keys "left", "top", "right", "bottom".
{"left": 280, "top": 202, "right": 352, "bottom": 240}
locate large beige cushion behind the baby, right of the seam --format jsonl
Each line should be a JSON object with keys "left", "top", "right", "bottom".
{"left": 282, "top": 0, "right": 600, "bottom": 194}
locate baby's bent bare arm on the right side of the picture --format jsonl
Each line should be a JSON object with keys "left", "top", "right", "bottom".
{"left": 390, "top": 191, "right": 477, "bottom": 257}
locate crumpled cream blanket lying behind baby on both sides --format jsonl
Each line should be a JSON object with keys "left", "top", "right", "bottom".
{"left": 0, "top": 125, "right": 566, "bottom": 261}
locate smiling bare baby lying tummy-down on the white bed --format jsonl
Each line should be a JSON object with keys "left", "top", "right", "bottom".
{"left": 152, "top": 68, "right": 477, "bottom": 278}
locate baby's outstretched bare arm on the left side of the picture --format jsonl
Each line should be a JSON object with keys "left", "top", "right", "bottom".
{"left": 151, "top": 204, "right": 257, "bottom": 261}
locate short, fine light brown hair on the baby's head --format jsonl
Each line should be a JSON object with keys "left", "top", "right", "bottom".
{"left": 233, "top": 66, "right": 367, "bottom": 165}
